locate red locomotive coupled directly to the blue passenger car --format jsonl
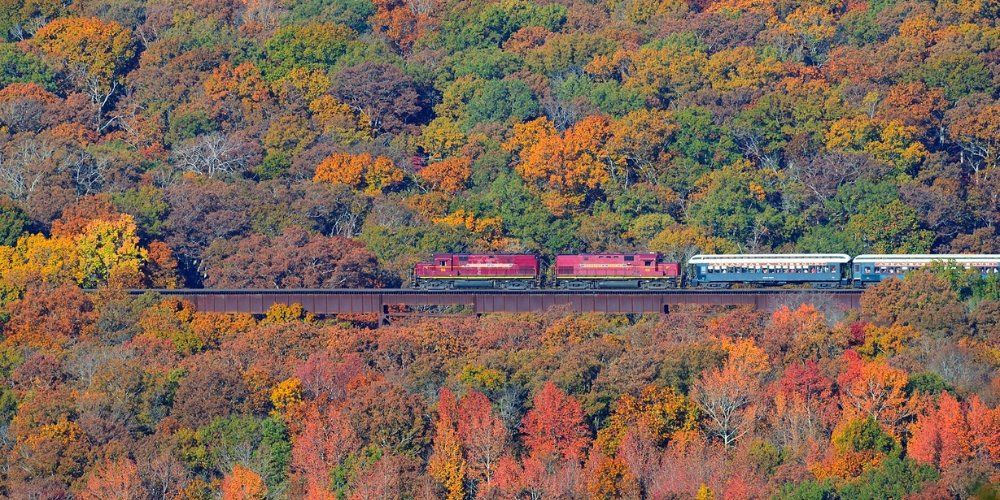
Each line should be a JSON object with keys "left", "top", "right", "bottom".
{"left": 555, "top": 253, "right": 681, "bottom": 290}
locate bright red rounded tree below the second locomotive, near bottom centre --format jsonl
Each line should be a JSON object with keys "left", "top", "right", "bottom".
{"left": 521, "top": 382, "right": 590, "bottom": 461}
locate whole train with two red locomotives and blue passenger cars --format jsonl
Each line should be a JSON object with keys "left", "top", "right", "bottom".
{"left": 412, "top": 252, "right": 1000, "bottom": 290}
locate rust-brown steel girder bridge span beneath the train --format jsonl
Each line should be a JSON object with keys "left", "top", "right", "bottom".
{"left": 131, "top": 289, "right": 861, "bottom": 321}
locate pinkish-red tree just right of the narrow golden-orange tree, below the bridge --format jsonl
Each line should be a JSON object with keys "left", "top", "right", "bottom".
{"left": 458, "top": 391, "right": 507, "bottom": 484}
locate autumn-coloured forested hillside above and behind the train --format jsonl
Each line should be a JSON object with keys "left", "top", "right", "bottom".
{"left": 0, "top": 0, "right": 1000, "bottom": 286}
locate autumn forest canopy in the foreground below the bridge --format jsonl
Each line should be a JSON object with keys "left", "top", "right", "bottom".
{"left": 0, "top": 278, "right": 1000, "bottom": 499}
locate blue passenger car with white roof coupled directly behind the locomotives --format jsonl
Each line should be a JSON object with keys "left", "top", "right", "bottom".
{"left": 688, "top": 254, "right": 851, "bottom": 288}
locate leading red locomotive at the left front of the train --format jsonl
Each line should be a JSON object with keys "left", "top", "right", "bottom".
{"left": 413, "top": 254, "right": 539, "bottom": 290}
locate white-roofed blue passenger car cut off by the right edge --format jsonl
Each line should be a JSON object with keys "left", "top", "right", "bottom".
{"left": 852, "top": 254, "right": 1000, "bottom": 286}
